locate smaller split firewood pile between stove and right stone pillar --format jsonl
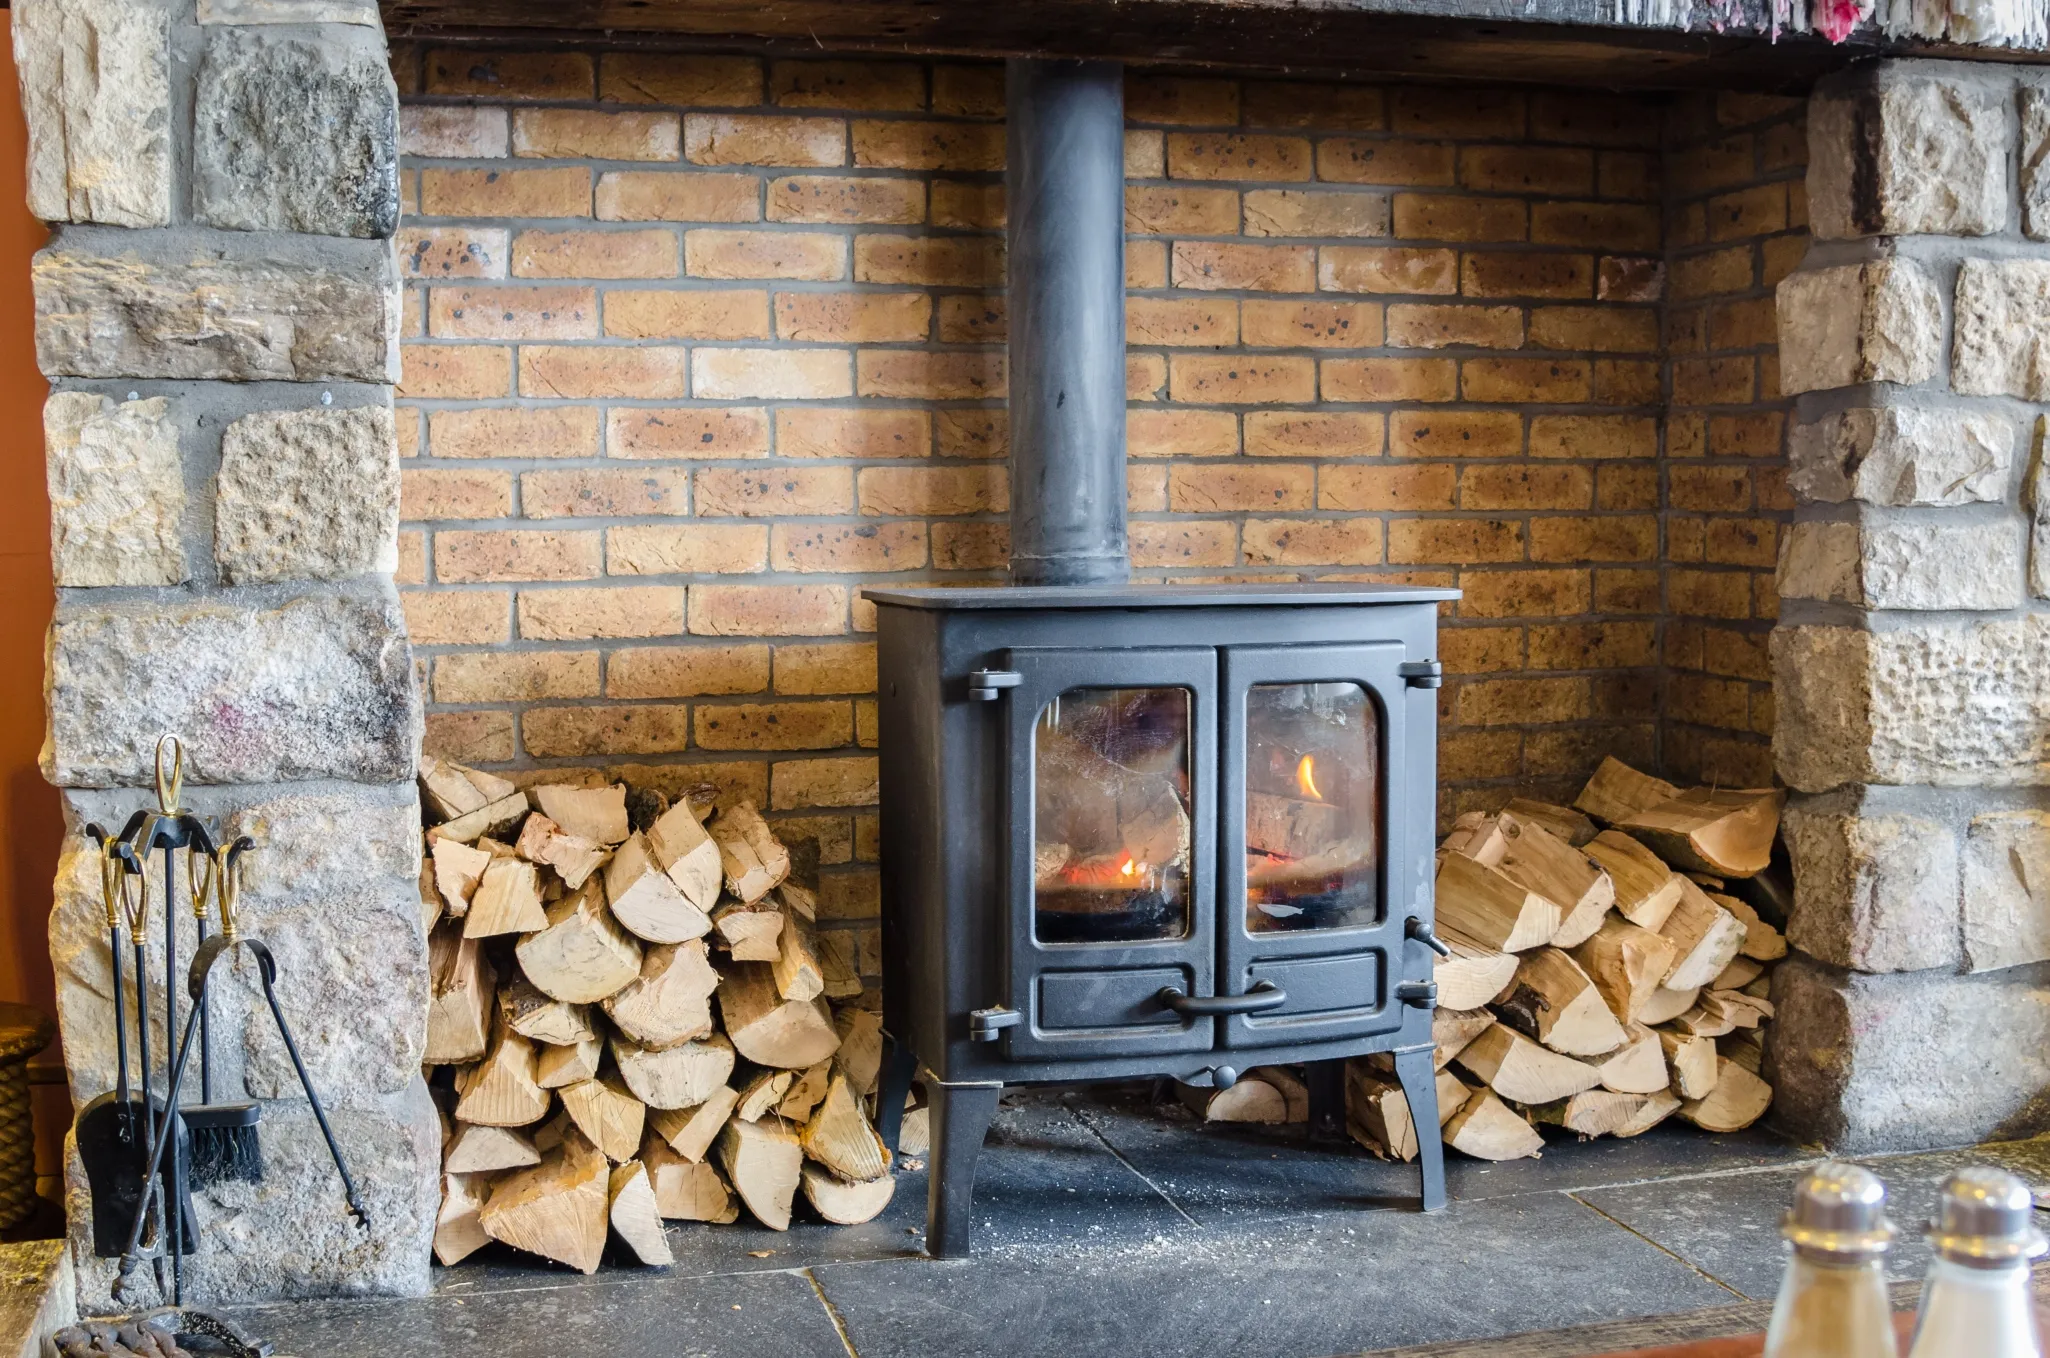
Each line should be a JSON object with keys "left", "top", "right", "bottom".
{"left": 1347, "top": 759, "right": 1788, "bottom": 1159}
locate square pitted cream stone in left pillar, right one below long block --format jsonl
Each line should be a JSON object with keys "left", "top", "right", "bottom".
{"left": 213, "top": 406, "right": 400, "bottom": 585}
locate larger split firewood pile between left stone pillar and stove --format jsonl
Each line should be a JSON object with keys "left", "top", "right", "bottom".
{"left": 420, "top": 759, "right": 894, "bottom": 1272}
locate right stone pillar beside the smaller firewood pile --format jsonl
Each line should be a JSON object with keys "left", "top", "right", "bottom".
{"left": 1769, "top": 62, "right": 2050, "bottom": 1151}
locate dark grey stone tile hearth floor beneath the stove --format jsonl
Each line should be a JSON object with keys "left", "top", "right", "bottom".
{"left": 238, "top": 1089, "right": 2050, "bottom": 1358}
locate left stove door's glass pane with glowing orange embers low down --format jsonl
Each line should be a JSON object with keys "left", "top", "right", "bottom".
{"left": 1033, "top": 687, "right": 1191, "bottom": 944}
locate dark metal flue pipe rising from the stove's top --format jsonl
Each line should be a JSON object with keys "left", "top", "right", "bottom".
{"left": 1005, "top": 57, "right": 1132, "bottom": 585}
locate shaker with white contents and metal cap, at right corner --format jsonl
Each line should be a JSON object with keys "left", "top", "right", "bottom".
{"left": 1909, "top": 1165, "right": 2046, "bottom": 1358}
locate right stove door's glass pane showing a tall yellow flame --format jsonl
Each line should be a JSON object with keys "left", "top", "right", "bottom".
{"left": 1246, "top": 683, "right": 1382, "bottom": 933}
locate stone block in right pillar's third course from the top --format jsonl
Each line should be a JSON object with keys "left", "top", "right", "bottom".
{"left": 1788, "top": 406, "right": 2015, "bottom": 507}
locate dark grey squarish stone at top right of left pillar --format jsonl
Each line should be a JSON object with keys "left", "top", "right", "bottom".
{"left": 193, "top": 27, "right": 398, "bottom": 238}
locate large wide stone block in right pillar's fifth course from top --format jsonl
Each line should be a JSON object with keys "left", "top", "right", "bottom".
{"left": 1771, "top": 615, "right": 2050, "bottom": 792}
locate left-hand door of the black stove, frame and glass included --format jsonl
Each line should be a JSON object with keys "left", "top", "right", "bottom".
{"left": 998, "top": 646, "right": 1218, "bottom": 1059}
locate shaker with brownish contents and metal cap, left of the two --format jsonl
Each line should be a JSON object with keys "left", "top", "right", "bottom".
{"left": 1765, "top": 1163, "right": 1900, "bottom": 1358}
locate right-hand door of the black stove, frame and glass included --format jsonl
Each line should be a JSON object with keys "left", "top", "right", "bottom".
{"left": 1218, "top": 642, "right": 1429, "bottom": 1048}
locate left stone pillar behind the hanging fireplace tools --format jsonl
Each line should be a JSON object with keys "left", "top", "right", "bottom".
{"left": 14, "top": 0, "right": 441, "bottom": 1311}
